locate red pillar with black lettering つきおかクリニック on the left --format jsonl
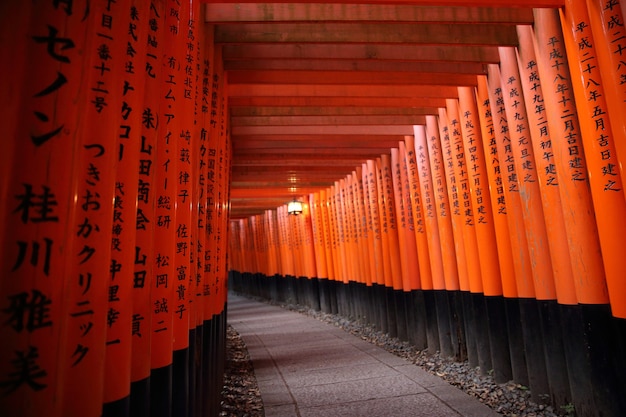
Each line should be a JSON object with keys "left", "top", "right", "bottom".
{"left": 57, "top": 1, "right": 132, "bottom": 416}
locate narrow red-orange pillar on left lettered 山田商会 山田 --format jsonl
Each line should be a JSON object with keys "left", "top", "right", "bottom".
{"left": 129, "top": 0, "right": 165, "bottom": 415}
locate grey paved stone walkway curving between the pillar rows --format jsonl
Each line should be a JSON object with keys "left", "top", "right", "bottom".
{"left": 228, "top": 294, "right": 499, "bottom": 417}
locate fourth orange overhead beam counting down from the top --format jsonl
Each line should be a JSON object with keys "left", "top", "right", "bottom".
{"left": 224, "top": 58, "right": 491, "bottom": 75}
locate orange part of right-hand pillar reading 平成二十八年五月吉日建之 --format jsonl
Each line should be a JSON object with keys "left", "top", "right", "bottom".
{"left": 561, "top": 1, "right": 626, "bottom": 318}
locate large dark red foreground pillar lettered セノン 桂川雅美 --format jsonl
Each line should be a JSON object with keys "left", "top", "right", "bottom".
{"left": 0, "top": 3, "right": 97, "bottom": 417}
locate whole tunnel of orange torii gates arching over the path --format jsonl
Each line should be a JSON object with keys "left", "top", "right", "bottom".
{"left": 0, "top": 0, "right": 626, "bottom": 417}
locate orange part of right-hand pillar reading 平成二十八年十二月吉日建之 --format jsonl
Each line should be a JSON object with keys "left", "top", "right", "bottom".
{"left": 534, "top": 10, "right": 608, "bottom": 304}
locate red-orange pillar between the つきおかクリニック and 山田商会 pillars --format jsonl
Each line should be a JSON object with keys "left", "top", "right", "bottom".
{"left": 102, "top": 1, "right": 154, "bottom": 416}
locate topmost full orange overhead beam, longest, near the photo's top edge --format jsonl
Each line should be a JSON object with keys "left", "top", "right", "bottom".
{"left": 205, "top": 2, "right": 533, "bottom": 24}
